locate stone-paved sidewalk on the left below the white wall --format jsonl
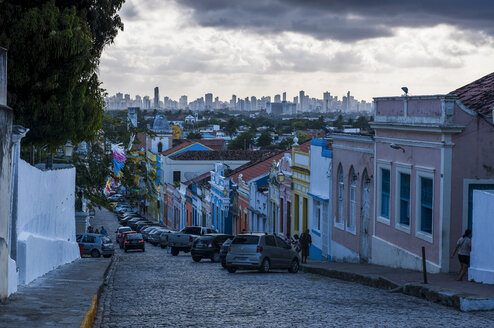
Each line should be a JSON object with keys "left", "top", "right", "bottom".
{"left": 0, "top": 210, "right": 115, "bottom": 328}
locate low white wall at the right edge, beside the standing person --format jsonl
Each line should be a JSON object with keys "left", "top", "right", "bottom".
{"left": 468, "top": 190, "right": 494, "bottom": 284}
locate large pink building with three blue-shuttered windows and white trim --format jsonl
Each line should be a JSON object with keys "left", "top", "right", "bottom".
{"left": 371, "top": 73, "right": 494, "bottom": 272}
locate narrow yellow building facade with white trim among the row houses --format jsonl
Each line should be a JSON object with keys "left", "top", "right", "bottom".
{"left": 292, "top": 141, "right": 310, "bottom": 236}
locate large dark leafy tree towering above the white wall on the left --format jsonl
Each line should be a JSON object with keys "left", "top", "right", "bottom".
{"left": 0, "top": 0, "right": 124, "bottom": 152}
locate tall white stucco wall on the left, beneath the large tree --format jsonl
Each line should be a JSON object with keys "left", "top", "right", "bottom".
{"left": 14, "top": 160, "right": 80, "bottom": 284}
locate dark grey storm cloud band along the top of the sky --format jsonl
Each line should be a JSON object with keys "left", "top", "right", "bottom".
{"left": 176, "top": 0, "right": 494, "bottom": 42}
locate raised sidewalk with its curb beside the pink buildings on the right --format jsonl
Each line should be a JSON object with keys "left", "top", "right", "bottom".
{"left": 301, "top": 260, "right": 494, "bottom": 311}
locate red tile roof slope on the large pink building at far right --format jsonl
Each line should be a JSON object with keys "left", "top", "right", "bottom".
{"left": 450, "top": 73, "right": 494, "bottom": 114}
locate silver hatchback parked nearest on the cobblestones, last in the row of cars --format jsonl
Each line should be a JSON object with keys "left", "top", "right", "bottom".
{"left": 226, "top": 233, "right": 300, "bottom": 273}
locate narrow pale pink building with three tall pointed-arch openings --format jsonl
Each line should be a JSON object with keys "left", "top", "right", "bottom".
{"left": 330, "top": 133, "right": 374, "bottom": 262}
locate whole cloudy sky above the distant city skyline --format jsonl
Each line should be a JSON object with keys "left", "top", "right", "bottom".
{"left": 100, "top": 0, "right": 494, "bottom": 101}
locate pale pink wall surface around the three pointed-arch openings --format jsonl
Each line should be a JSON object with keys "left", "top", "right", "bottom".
{"left": 331, "top": 134, "right": 374, "bottom": 262}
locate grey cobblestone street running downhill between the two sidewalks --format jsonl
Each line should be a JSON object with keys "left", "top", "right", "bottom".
{"left": 95, "top": 212, "right": 494, "bottom": 327}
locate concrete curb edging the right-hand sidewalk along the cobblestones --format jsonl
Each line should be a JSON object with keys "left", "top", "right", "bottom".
{"left": 301, "top": 265, "right": 494, "bottom": 312}
